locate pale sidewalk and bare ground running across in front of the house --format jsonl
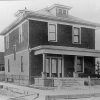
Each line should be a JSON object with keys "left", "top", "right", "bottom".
{"left": 0, "top": 82, "right": 100, "bottom": 100}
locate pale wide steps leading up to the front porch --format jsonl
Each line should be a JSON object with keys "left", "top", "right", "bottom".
{"left": 57, "top": 78, "right": 84, "bottom": 87}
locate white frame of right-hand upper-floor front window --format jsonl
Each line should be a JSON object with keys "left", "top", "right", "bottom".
{"left": 72, "top": 26, "right": 81, "bottom": 44}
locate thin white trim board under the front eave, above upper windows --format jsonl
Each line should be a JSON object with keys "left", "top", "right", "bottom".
{"left": 28, "top": 18, "right": 96, "bottom": 29}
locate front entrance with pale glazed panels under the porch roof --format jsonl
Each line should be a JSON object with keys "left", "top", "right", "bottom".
{"left": 46, "top": 57, "right": 62, "bottom": 77}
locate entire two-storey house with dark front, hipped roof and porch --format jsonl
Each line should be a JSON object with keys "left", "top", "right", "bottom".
{"left": 1, "top": 4, "right": 100, "bottom": 86}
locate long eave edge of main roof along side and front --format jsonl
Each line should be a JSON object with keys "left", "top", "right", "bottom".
{"left": 0, "top": 12, "right": 100, "bottom": 35}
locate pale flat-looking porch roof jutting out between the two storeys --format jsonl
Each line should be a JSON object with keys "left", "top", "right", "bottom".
{"left": 30, "top": 45, "right": 100, "bottom": 58}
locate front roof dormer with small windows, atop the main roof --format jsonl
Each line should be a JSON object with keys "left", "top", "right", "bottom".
{"left": 47, "top": 4, "right": 71, "bottom": 17}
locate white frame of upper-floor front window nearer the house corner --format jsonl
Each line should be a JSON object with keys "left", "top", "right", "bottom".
{"left": 48, "top": 22, "right": 57, "bottom": 42}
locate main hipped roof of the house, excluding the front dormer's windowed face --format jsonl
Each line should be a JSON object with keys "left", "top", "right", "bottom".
{"left": 1, "top": 4, "right": 100, "bottom": 35}
